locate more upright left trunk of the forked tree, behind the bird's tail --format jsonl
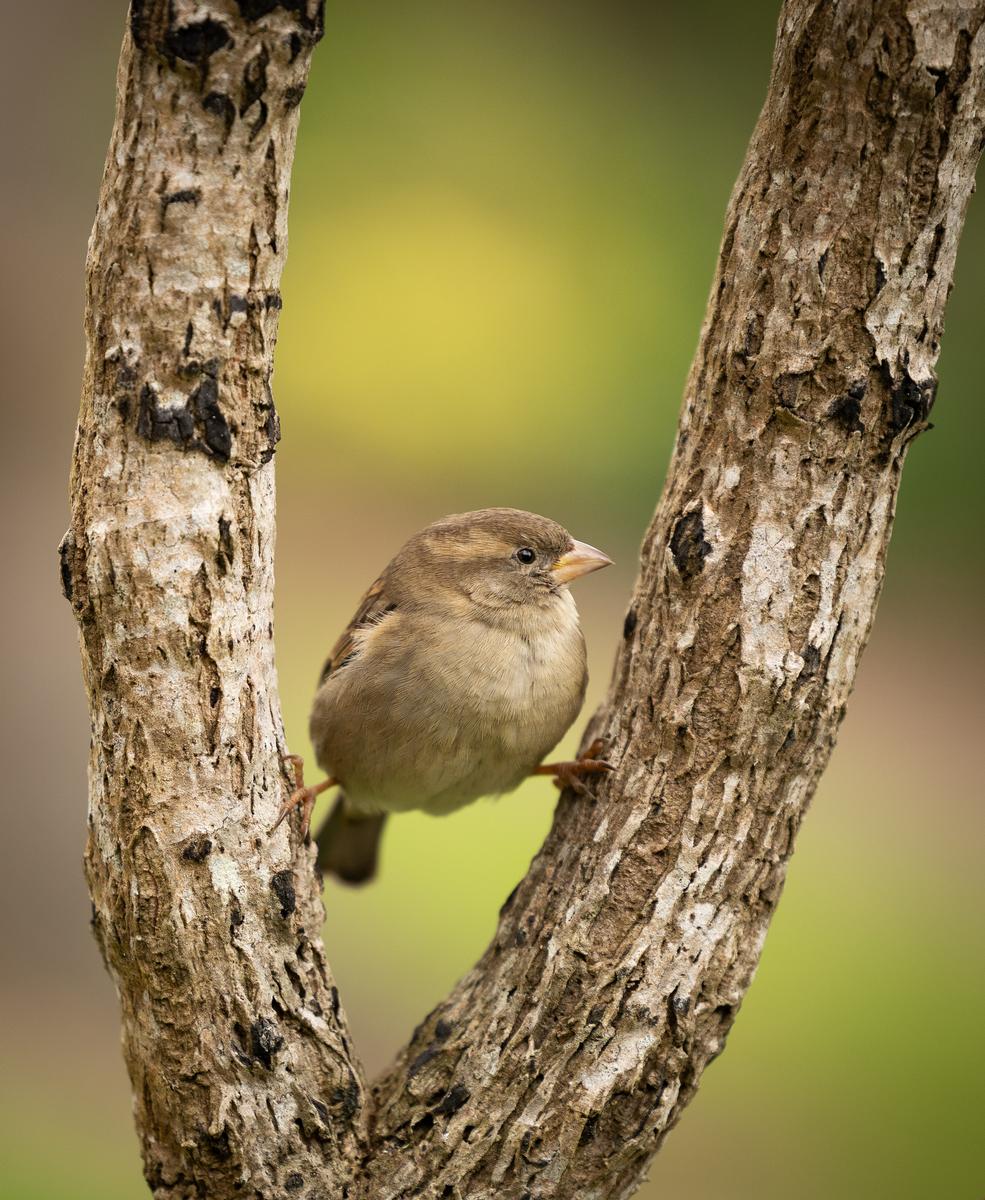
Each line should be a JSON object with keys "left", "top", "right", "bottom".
{"left": 62, "top": 0, "right": 362, "bottom": 1198}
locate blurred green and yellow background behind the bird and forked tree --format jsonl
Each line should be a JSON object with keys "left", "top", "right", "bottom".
{"left": 0, "top": 0, "right": 985, "bottom": 1200}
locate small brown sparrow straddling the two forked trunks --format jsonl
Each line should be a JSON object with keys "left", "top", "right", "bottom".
{"left": 270, "top": 508, "right": 612, "bottom": 883}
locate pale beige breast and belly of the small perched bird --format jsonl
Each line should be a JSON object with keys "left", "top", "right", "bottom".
{"left": 311, "top": 588, "right": 587, "bottom": 815}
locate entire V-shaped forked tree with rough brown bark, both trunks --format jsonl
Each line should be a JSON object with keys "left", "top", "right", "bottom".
{"left": 62, "top": 0, "right": 985, "bottom": 1200}
